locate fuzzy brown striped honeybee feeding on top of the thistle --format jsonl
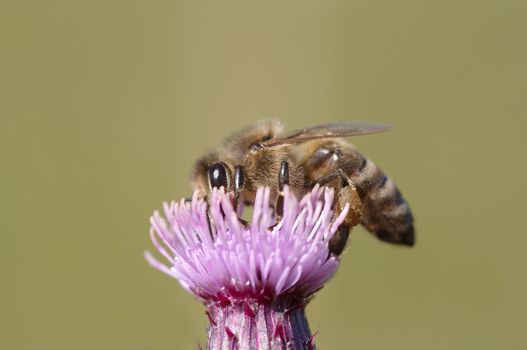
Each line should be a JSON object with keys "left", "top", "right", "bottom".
{"left": 191, "top": 120, "right": 415, "bottom": 256}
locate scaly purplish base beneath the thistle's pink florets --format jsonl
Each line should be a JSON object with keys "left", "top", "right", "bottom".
{"left": 207, "top": 302, "right": 315, "bottom": 350}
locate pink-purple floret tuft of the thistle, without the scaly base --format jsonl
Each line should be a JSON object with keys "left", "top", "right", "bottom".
{"left": 145, "top": 185, "right": 348, "bottom": 304}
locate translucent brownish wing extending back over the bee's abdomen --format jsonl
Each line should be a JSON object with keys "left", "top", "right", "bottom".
{"left": 262, "top": 121, "right": 393, "bottom": 147}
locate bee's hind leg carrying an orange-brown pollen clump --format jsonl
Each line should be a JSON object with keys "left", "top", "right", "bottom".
{"left": 316, "top": 169, "right": 362, "bottom": 256}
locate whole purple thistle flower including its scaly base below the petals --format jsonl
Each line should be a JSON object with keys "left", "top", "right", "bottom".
{"left": 145, "top": 185, "right": 349, "bottom": 349}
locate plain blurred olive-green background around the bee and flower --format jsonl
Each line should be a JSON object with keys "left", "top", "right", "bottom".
{"left": 0, "top": 0, "right": 527, "bottom": 350}
